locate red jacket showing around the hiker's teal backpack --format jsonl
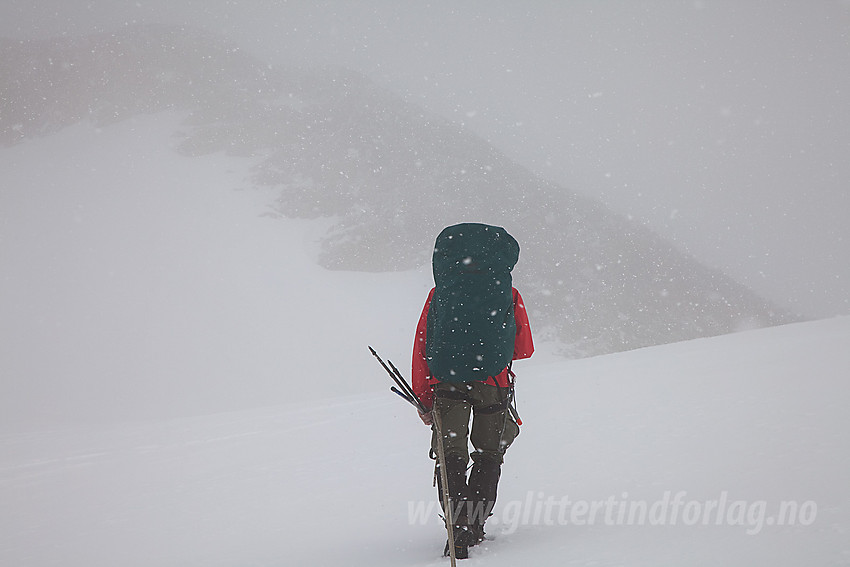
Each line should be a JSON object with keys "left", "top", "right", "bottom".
{"left": 412, "top": 288, "right": 534, "bottom": 408}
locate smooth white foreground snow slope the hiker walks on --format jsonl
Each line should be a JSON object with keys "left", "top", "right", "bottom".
{"left": 0, "top": 318, "right": 850, "bottom": 567}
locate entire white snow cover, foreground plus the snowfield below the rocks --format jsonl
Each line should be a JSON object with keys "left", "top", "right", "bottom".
{"left": 0, "top": 115, "right": 850, "bottom": 567}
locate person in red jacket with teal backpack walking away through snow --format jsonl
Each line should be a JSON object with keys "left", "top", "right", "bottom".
{"left": 412, "top": 223, "right": 534, "bottom": 558}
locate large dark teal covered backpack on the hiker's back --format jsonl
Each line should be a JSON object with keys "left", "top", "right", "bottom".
{"left": 425, "top": 223, "right": 519, "bottom": 383}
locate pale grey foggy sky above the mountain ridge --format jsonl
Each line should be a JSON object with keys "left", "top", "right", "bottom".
{"left": 0, "top": 0, "right": 850, "bottom": 316}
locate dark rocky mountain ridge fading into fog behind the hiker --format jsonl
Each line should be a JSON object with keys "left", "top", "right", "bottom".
{"left": 0, "top": 25, "right": 798, "bottom": 357}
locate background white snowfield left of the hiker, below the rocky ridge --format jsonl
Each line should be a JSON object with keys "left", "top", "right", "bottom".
{"left": 0, "top": 113, "right": 431, "bottom": 431}
